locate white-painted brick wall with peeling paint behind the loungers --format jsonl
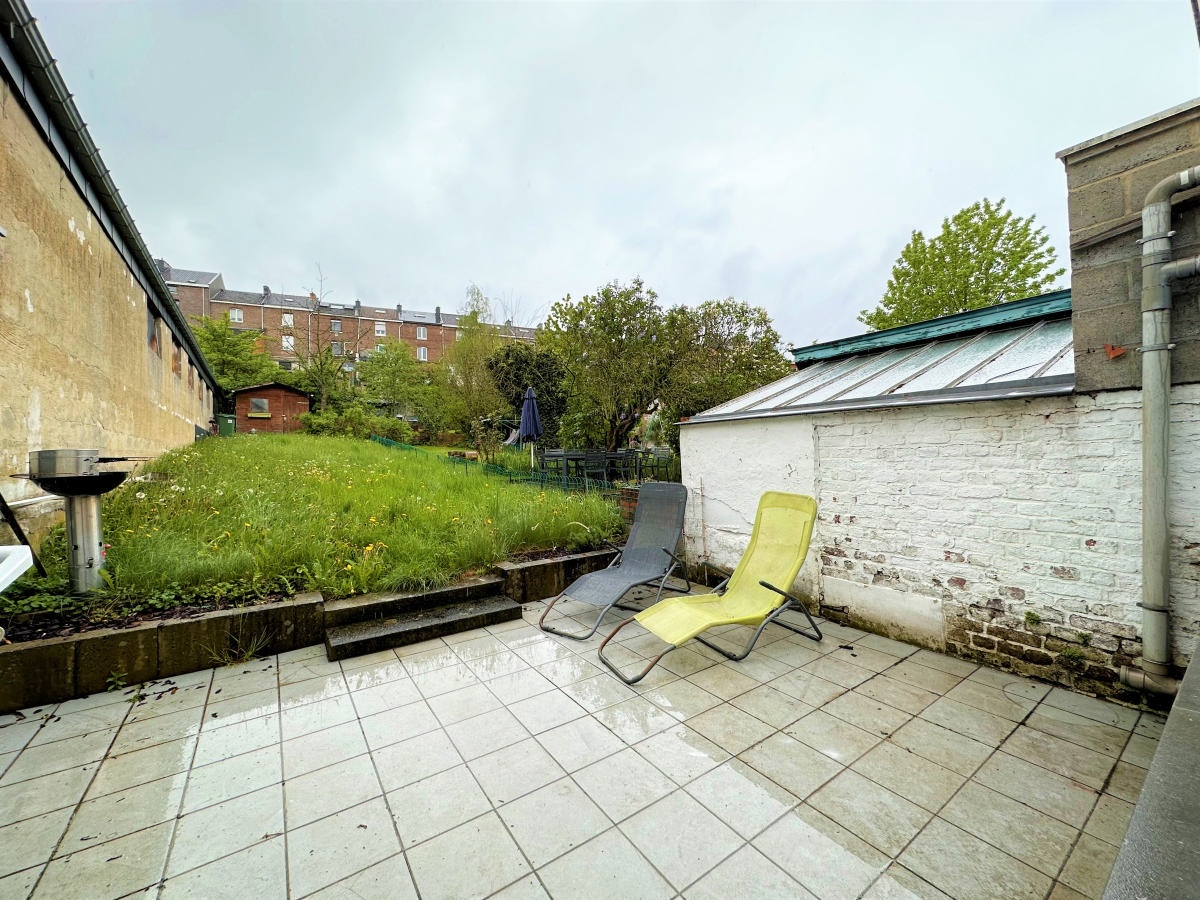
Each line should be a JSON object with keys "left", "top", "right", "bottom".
{"left": 680, "top": 385, "right": 1200, "bottom": 694}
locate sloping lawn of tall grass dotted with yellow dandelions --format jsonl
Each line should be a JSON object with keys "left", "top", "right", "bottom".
{"left": 90, "top": 434, "right": 622, "bottom": 596}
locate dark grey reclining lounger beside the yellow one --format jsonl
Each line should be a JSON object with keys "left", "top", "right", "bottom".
{"left": 538, "top": 484, "right": 691, "bottom": 641}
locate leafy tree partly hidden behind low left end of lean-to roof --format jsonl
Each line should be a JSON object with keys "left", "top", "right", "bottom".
{"left": 662, "top": 296, "right": 790, "bottom": 443}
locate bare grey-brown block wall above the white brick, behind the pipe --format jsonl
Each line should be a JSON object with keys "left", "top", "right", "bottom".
{"left": 1058, "top": 101, "right": 1200, "bottom": 391}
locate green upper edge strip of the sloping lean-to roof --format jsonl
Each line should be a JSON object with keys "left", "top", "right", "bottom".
{"left": 791, "top": 294, "right": 1070, "bottom": 365}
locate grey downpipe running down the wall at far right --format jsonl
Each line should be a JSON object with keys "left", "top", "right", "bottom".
{"left": 1121, "top": 166, "right": 1200, "bottom": 694}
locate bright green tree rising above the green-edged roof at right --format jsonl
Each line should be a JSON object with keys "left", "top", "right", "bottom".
{"left": 858, "top": 198, "right": 1066, "bottom": 331}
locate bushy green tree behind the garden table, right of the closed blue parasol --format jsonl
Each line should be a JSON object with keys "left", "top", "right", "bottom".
{"left": 538, "top": 278, "right": 676, "bottom": 450}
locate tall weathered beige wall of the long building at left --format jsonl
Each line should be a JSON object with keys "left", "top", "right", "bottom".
{"left": 0, "top": 79, "right": 212, "bottom": 511}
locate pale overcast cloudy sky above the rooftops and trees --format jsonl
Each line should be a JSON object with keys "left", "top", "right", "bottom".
{"left": 28, "top": 0, "right": 1200, "bottom": 346}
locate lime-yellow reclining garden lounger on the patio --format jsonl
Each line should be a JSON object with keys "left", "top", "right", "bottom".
{"left": 598, "top": 487, "right": 821, "bottom": 684}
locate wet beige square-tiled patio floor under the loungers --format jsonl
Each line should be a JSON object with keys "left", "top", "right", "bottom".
{"left": 0, "top": 604, "right": 1163, "bottom": 900}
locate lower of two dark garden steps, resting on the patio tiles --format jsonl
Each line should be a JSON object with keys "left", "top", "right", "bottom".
{"left": 325, "top": 594, "right": 521, "bottom": 660}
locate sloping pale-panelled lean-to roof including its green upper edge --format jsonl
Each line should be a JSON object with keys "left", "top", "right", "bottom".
{"left": 690, "top": 290, "right": 1075, "bottom": 422}
